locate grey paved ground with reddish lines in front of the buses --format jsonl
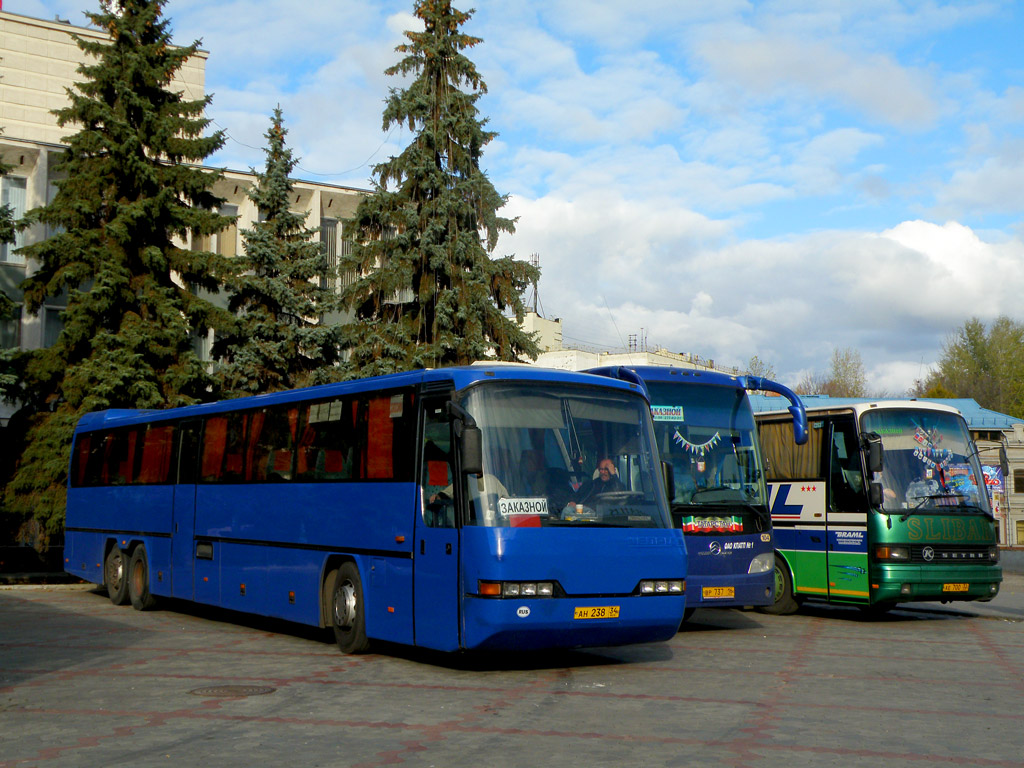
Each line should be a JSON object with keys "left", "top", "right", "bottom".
{"left": 0, "top": 573, "right": 1024, "bottom": 768}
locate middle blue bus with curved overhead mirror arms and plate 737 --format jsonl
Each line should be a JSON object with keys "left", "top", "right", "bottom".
{"left": 591, "top": 366, "right": 807, "bottom": 617}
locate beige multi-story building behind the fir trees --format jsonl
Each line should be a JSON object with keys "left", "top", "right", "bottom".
{"left": 0, "top": 7, "right": 367, "bottom": 425}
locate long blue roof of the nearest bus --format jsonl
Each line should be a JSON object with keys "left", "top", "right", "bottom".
{"left": 75, "top": 362, "right": 640, "bottom": 432}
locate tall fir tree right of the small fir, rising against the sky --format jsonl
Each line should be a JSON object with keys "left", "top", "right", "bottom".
{"left": 340, "top": 0, "right": 538, "bottom": 376}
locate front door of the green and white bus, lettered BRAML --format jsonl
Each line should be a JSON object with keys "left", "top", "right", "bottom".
{"left": 825, "top": 414, "right": 870, "bottom": 601}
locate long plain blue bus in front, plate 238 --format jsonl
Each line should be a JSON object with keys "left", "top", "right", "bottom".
{"left": 65, "top": 366, "right": 686, "bottom": 652}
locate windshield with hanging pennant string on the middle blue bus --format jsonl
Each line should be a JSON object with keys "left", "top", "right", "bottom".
{"left": 647, "top": 382, "right": 765, "bottom": 505}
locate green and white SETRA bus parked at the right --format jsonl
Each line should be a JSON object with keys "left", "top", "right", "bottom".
{"left": 757, "top": 400, "right": 1002, "bottom": 613}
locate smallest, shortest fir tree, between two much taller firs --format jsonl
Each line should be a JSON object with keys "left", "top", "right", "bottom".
{"left": 213, "top": 106, "right": 339, "bottom": 395}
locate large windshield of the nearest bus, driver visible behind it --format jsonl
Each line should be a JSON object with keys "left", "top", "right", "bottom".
{"left": 463, "top": 383, "right": 671, "bottom": 527}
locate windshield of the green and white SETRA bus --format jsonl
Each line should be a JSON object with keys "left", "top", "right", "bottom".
{"left": 861, "top": 409, "right": 991, "bottom": 515}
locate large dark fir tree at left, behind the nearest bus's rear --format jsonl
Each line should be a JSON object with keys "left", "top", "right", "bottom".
{"left": 5, "top": 0, "right": 229, "bottom": 548}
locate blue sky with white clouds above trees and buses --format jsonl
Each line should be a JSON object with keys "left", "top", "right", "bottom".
{"left": 16, "top": 0, "right": 1024, "bottom": 393}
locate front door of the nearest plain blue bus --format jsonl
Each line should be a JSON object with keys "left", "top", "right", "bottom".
{"left": 413, "top": 396, "right": 461, "bottom": 650}
